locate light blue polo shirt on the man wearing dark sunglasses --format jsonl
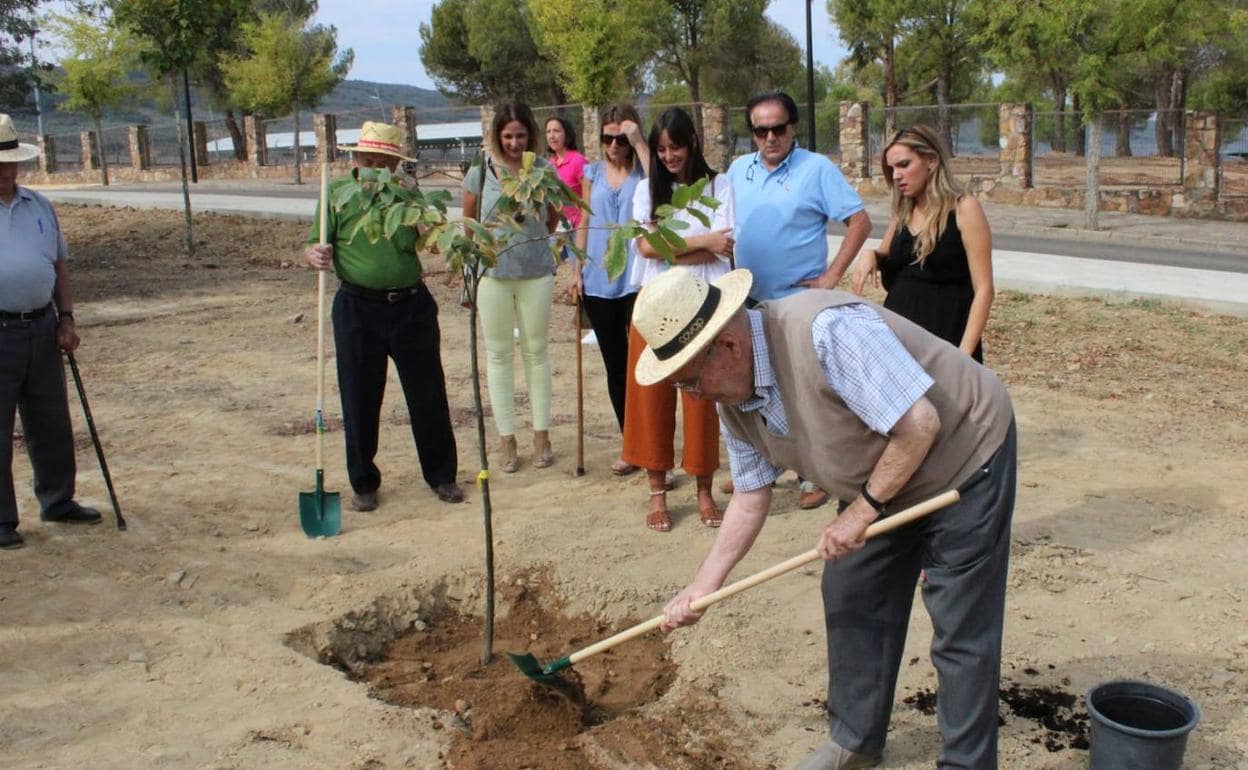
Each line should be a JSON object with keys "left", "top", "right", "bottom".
{"left": 728, "top": 147, "right": 862, "bottom": 302}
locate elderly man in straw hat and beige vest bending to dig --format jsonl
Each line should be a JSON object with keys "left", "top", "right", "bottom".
{"left": 633, "top": 268, "right": 1017, "bottom": 770}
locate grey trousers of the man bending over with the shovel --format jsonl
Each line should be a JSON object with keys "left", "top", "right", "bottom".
{"left": 822, "top": 422, "right": 1018, "bottom": 770}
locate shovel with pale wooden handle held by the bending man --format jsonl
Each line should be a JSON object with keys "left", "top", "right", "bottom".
{"left": 507, "top": 489, "right": 961, "bottom": 688}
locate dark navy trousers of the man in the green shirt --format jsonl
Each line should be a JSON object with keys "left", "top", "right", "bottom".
{"left": 333, "top": 283, "right": 458, "bottom": 492}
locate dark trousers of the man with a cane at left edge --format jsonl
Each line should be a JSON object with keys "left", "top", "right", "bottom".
{"left": 0, "top": 312, "right": 77, "bottom": 527}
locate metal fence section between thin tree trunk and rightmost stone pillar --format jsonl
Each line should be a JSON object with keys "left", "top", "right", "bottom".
{"left": 1088, "top": 110, "right": 1183, "bottom": 187}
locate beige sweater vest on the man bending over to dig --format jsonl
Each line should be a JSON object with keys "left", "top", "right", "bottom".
{"left": 720, "top": 290, "right": 1013, "bottom": 510}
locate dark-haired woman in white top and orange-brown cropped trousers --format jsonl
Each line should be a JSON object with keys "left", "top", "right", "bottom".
{"left": 624, "top": 107, "right": 734, "bottom": 532}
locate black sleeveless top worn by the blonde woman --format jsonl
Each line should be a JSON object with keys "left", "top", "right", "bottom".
{"left": 879, "top": 211, "right": 983, "bottom": 363}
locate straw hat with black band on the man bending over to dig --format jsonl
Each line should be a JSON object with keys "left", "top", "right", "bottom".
{"left": 633, "top": 267, "right": 754, "bottom": 384}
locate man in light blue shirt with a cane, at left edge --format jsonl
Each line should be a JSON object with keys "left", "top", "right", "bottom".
{"left": 0, "top": 115, "right": 100, "bottom": 548}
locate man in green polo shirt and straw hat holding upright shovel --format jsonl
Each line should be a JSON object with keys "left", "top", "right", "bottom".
{"left": 303, "top": 122, "right": 464, "bottom": 510}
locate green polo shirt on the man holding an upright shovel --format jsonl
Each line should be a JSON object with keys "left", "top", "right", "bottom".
{"left": 308, "top": 171, "right": 421, "bottom": 290}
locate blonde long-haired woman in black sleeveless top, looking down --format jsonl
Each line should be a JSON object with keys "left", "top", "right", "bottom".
{"left": 854, "top": 125, "right": 993, "bottom": 363}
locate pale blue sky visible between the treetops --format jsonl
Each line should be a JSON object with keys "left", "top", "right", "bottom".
{"left": 316, "top": 0, "right": 846, "bottom": 89}
